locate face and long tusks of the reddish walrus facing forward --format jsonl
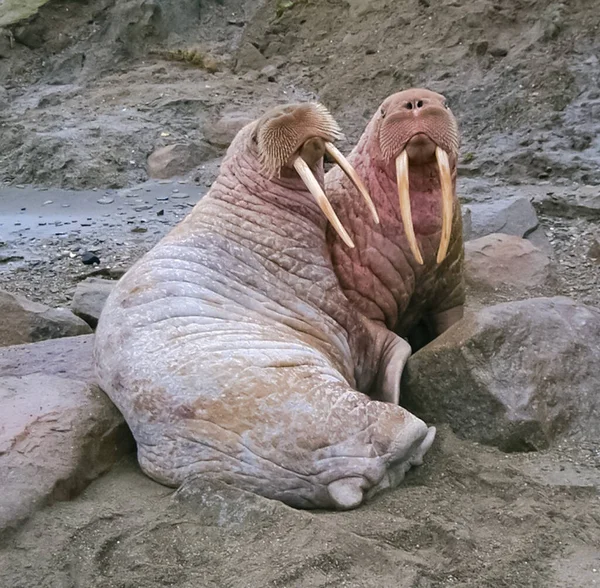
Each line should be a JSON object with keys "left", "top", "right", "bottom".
{"left": 376, "top": 89, "right": 460, "bottom": 264}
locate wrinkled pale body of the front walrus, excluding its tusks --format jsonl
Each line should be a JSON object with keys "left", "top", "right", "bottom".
{"left": 94, "top": 105, "right": 435, "bottom": 509}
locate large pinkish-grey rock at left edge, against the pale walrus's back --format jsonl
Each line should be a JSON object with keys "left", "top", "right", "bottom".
{"left": 0, "top": 337, "right": 134, "bottom": 535}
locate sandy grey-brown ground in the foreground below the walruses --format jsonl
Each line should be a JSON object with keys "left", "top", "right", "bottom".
{"left": 0, "top": 429, "right": 600, "bottom": 588}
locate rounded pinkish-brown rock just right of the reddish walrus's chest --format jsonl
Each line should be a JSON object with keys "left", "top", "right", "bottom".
{"left": 465, "top": 233, "right": 550, "bottom": 291}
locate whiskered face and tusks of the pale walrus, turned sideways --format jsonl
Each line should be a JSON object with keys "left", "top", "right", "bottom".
{"left": 252, "top": 103, "right": 379, "bottom": 248}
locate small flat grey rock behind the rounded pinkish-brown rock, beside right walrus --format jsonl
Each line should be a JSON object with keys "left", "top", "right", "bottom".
{"left": 465, "top": 198, "right": 539, "bottom": 239}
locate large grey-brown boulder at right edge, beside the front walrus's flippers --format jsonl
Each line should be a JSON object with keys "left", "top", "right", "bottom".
{"left": 401, "top": 297, "right": 600, "bottom": 451}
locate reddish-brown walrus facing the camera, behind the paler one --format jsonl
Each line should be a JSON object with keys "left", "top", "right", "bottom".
{"left": 325, "top": 88, "right": 465, "bottom": 347}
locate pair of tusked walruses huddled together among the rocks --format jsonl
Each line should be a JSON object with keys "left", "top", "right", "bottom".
{"left": 95, "top": 89, "right": 464, "bottom": 509}
